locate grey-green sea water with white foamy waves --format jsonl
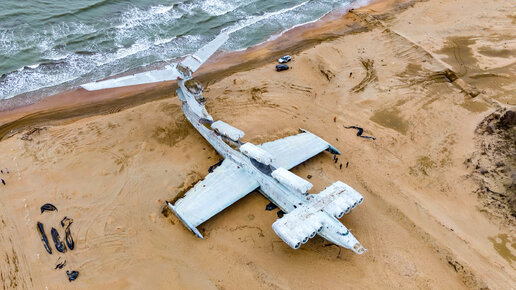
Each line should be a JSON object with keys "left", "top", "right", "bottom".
{"left": 0, "top": 0, "right": 365, "bottom": 100}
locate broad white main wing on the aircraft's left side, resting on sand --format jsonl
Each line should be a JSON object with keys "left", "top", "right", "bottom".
{"left": 167, "top": 159, "right": 259, "bottom": 238}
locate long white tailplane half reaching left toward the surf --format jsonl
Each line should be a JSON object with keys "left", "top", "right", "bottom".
{"left": 81, "top": 65, "right": 179, "bottom": 91}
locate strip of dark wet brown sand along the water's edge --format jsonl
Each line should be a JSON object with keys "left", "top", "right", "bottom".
{"left": 0, "top": 0, "right": 404, "bottom": 140}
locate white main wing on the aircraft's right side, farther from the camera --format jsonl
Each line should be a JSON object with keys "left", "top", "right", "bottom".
{"left": 259, "top": 130, "right": 340, "bottom": 170}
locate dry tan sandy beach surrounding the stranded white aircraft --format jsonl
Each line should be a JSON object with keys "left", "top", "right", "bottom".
{"left": 0, "top": 0, "right": 516, "bottom": 289}
